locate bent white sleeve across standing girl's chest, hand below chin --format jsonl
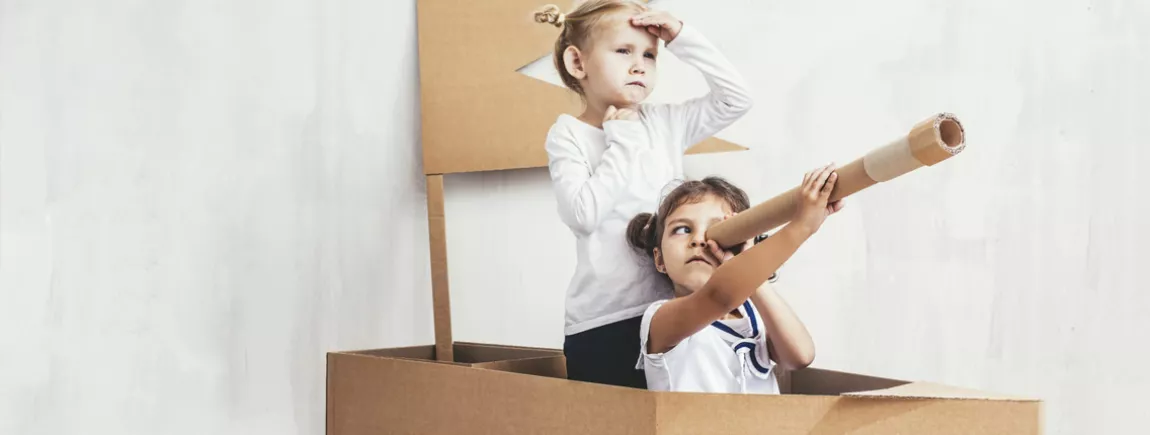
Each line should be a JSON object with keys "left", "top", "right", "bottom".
{"left": 546, "top": 120, "right": 651, "bottom": 234}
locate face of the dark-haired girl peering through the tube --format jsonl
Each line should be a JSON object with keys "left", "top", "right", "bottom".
{"left": 654, "top": 193, "right": 730, "bottom": 296}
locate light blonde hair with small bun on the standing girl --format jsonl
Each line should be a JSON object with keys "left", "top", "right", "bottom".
{"left": 535, "top": 0, "right": 646, "bottom": 97}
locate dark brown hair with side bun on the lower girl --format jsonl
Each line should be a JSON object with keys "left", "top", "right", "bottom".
{"left": 627, "top": 176, "right": 751, "bottom": 259}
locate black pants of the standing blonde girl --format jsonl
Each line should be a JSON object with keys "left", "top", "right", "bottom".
{"left": 564, "top": 316, "right": 646, "bottom": 390}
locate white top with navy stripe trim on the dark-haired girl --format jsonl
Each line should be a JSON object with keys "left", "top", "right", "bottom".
{"left": 635, "top": 300, "right": 779, "bottom": 395}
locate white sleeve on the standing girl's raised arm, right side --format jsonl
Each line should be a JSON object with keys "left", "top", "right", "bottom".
{"left": 666, "top": 24, "right": 753, "bottom": 151}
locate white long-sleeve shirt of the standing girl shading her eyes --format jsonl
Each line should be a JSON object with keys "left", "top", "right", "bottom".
{"left": 546, "top": 24, "right": 752, "bottom": 335}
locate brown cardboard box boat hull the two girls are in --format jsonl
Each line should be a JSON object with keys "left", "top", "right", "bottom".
{"left": 327, "top": 343, "right": 1042, "bottom": 435}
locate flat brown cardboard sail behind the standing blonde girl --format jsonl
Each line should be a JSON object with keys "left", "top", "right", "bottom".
{"left": 419, "top": 0, "right": 746, "bottom": 174}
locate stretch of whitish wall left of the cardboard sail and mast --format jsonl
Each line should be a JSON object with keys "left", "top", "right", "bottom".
{"left": 0, "top": 0, "right": 432, "bottom": 435}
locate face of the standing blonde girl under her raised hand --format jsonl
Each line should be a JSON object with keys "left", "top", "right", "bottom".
{"left": 572, "top": 13, "right": 659, "bottom": 108}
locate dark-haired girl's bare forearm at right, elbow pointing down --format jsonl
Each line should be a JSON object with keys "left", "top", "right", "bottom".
{"left": 751, "top": 283, "right": 814, "bottom": 371}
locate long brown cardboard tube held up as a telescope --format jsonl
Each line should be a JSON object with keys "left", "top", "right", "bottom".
{"left": 706, "top": 113, "right": 966, "bottom": 247}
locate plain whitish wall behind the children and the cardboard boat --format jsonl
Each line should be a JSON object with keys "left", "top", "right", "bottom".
{"left": 0, "top": 0, "right": 1150, "bottom": 434}
